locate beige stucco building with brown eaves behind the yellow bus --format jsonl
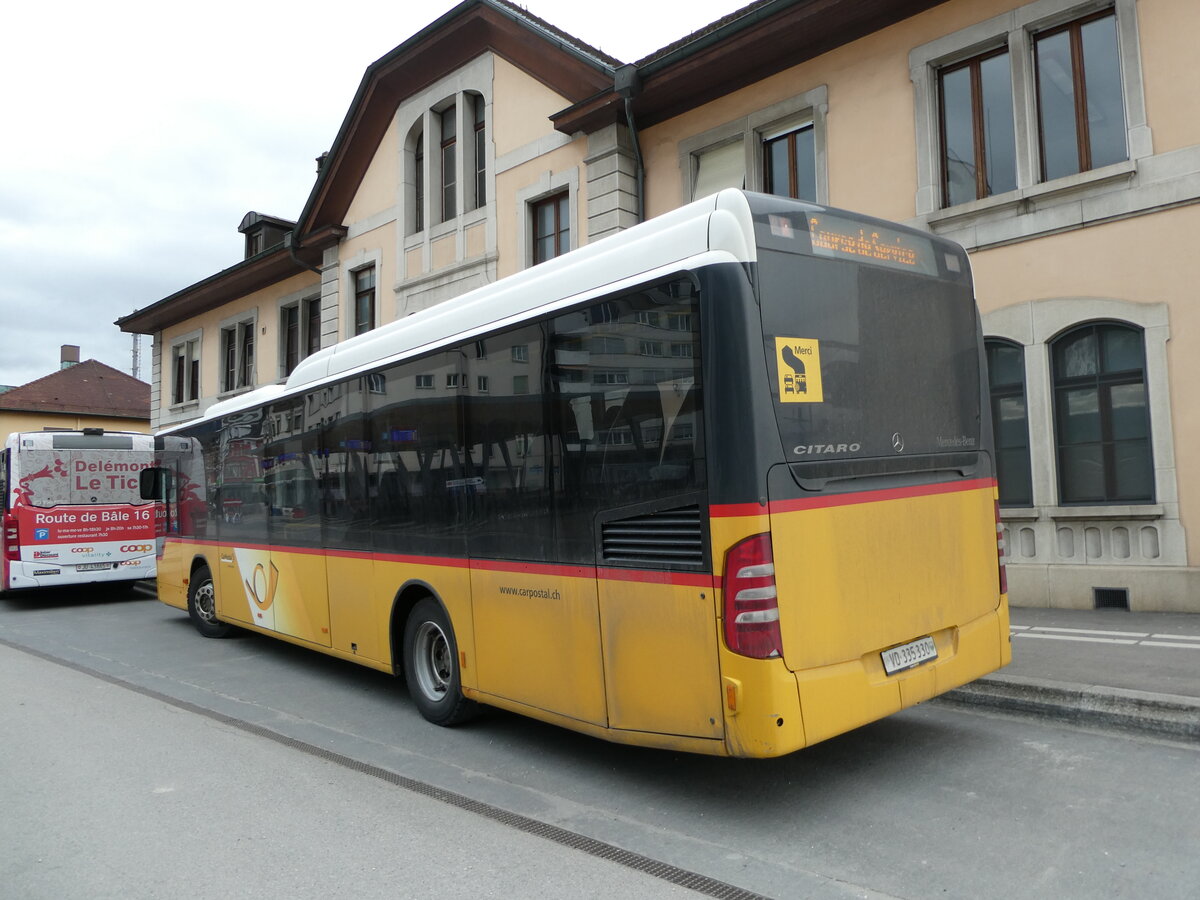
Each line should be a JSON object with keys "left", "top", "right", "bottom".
{"left": 119, "top": 0, "right": 1200, "bottom": 612}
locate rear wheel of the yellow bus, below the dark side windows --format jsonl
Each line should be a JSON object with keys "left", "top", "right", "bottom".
{"left": 404, "top": 596, "right": 478, "bottom": 725}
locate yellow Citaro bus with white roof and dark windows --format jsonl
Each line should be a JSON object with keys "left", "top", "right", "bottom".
{"left": 144, "top": 191, "right": 1009, "bottom": 757}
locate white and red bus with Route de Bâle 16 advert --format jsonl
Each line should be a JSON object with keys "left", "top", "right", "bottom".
{"left": 0, "top": 428, "right": 155, "bottom": 590}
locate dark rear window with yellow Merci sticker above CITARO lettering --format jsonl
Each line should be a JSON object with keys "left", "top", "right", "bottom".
{"left": 760, "top": 251, "right": 979, "bottom": 462}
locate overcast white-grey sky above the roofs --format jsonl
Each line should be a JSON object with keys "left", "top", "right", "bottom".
{"left": 0, "top": 0, "right": 745, "bottom": 385}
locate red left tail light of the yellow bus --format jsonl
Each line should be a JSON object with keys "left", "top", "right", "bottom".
{"left": 722, "top": 534, "right": 784, "bottom": 659}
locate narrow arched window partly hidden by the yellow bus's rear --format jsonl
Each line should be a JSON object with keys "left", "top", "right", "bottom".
{"left": 984, "top": 338, "right": 1033, "bottom": 506}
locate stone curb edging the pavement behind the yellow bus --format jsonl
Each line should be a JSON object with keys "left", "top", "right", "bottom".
{"left": 938, "top": 674, "right": 1200, "bottom": 743}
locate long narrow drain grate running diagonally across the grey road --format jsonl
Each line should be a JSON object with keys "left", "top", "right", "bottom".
{"left": 0, "top": 638, "right": 769, "bottom": 900}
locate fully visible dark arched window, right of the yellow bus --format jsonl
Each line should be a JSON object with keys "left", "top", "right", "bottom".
{"left": 1050, "top": 322, "right": 1154, "bottom": 505}
